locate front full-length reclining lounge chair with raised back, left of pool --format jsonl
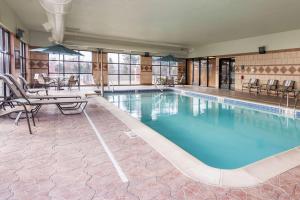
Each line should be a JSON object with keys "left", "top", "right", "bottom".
{"left": 0, "top": 75, "right": 88, "bottom": 115}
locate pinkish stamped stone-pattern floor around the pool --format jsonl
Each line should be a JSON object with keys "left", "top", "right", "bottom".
{"left": 0, "top": 97, "right": 300, "bottom": 200}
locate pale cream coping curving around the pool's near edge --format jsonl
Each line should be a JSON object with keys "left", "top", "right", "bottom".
{"left": 97, "top": 91, "right": 300, "bottom": 187}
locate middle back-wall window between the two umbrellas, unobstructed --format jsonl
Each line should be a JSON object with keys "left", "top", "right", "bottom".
{"left": 107, "top": 53, "right": 141, "bottom": 85}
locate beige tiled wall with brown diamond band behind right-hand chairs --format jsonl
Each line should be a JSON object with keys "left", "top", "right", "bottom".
{"left": 235, "top": 50, "right": 300, "bottom": 90}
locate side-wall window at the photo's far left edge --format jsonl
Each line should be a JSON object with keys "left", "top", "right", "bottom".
{"left": 0, "top": 27, "right": 10, "bottom": 97}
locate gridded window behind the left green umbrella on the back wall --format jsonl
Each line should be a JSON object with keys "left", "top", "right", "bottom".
{"left": 49, "top": 51, "right": 94, "bottom": 85}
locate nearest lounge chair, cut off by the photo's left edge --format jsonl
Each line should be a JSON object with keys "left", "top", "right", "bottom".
{"left": 0, "top": 99, "right": 35, "bottom": 134}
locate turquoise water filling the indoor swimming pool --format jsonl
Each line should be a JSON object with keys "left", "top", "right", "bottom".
{"left": 106, "top": 92, "right": 300, "bottom": 169}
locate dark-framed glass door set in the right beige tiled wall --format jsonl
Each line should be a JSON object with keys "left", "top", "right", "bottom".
{"left": 219, "top": 58, "right": 235, "bottom": 90}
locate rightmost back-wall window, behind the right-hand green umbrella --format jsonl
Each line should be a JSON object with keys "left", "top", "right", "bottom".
{"left": 152, "top": 57, "right": 178, "bottom": 84}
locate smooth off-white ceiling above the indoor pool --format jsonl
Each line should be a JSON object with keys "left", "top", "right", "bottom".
{"left": 6, "top": 0, "right": 300, "bottom": 47}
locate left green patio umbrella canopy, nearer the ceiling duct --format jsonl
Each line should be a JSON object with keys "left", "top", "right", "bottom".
{"left": 30, "top": 44, "right": 83, "bottom": 56}
